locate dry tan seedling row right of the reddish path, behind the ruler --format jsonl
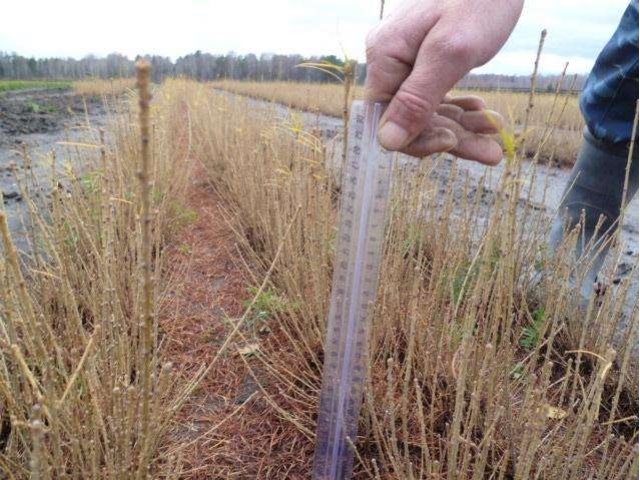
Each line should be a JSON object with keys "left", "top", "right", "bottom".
{"left": 185, "top": 78, "right": 638, "bottom": 479}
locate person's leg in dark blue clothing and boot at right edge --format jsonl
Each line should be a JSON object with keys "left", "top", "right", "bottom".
{"left": 550, "top": 0, "right": 638, "bottom": 298}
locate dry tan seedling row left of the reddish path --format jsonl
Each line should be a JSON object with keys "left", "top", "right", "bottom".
{"left": 0, "top": 73, "right": 197, "bottom": 478}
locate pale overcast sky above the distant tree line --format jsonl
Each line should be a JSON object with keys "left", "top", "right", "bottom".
{"left": 0, "top": 0, "right": 628, "bottom": 74}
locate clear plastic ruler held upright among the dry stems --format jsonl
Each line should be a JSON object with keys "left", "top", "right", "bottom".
{"left": 313, "top": 102, "right": 393, "bottom": 480}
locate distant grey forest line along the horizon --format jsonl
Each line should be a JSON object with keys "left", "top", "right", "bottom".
{"left": 0, "top": 50, "right": 586, "bottom": 92}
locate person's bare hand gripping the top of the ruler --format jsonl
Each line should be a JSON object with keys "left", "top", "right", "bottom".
{"left": 365, "top": 0, "right": 523, "bottom": 165}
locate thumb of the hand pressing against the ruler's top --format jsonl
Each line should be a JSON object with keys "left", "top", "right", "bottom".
{"left": 378, "top": 31, "right": 471, "bottom": 150}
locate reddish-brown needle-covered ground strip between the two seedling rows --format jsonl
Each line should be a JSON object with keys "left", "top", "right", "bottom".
{"left": 160, "top": 169, "right": 309, "bottom": 479}
